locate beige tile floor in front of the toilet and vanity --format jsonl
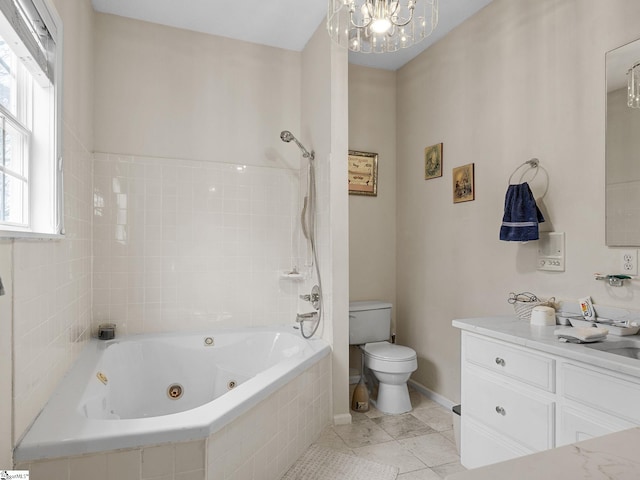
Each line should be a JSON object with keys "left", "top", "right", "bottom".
{"left": 316, "top": 385, "right": 464, "bottom": 480}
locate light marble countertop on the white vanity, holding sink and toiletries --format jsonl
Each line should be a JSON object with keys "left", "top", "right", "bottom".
{"left": 452, "top": 315, "right": 640, "bottom": 378}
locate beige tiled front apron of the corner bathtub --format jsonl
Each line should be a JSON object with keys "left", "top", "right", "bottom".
{"left": 16, "top": 356, "right": 331, "bottom": 480}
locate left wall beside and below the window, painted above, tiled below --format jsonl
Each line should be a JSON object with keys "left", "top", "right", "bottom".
{"left": 0, "top": 0, "right": 93, "bottom": 460}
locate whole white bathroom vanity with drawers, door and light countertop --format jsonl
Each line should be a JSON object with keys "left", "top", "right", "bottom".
{"left": 453, "top": 316, "right": 640, "bottom": 468}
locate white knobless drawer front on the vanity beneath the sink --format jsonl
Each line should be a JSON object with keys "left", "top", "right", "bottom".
{"left": 560, "top": 363, "right": 640, "bottom": 425}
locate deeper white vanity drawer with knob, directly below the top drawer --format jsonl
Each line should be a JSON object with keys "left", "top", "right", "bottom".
{"left": 462, "top": 366, "right": 555, "bottom": 451}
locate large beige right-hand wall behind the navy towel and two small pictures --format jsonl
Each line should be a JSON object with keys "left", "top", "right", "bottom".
{"left": 397, "top": 0, "right": 640, "bottom": 401}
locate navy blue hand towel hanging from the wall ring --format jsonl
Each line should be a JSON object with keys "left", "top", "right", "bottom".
{"left": 500, "top": 182, "right": 544, "bottom": 242}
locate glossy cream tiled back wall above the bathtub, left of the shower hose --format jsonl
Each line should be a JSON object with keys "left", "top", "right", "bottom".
{"left": 93, "top": 153, "right": 309, "bottom": 334}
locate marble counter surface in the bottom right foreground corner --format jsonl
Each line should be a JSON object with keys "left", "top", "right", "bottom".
{"left": 447, "top": 427, "right": 640, "bottom": 480}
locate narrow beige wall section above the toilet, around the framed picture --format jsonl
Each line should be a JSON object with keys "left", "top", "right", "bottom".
{"left": 349, "top": 65, "right": 396, "bottom": 307}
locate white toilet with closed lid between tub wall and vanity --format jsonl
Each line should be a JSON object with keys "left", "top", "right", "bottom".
{"left": 349, "top": 301, "right": 418, "bottom": 415}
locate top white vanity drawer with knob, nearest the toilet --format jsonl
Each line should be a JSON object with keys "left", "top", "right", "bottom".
{"left": 462, "top": 332, "right": 555, "bottom": 392}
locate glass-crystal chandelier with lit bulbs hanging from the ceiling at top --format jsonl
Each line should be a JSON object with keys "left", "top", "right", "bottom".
{"left": 327, "top": 0, "right": 438, "bottom": 53}
